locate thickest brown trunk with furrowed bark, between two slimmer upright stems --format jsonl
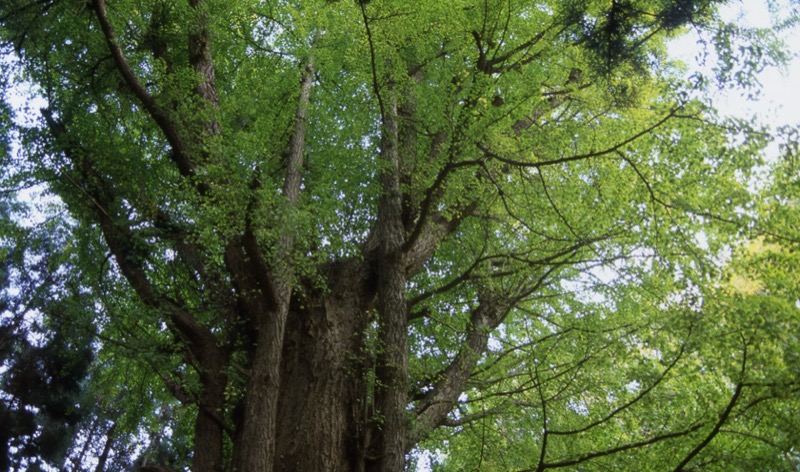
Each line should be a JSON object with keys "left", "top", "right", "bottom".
{"left": 274, "top": 274, "right": 368, "bottom": 472}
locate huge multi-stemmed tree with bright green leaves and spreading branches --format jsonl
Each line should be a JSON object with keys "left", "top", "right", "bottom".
{"left": 0, "top": 0, "right": 800, "bottom": 472}
